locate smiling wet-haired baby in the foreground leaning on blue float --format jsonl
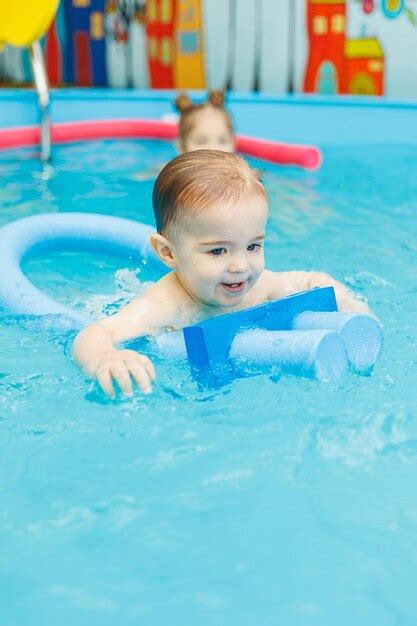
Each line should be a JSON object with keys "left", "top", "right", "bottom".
{"left": 73, "top": 150, "right": 369, "bottom": 397}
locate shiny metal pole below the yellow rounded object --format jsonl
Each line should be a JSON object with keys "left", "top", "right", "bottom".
{"left": 29, "top": 41, "right": 51, "bottom": 161}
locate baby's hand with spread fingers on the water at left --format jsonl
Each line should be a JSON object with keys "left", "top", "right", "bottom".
{"left": 88, "top": 349, "right": 155, "bottom": 398}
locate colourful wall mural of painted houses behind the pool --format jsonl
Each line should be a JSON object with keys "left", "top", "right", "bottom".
{"left": 0, "top": 0, "right": 417, "bottom": 98}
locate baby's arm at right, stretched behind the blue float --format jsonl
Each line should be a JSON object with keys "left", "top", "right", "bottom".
{"left": 268, "top": 271, "right": 372, "bottom": 314}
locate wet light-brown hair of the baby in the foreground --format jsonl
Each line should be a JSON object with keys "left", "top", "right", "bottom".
{"left": 152, "top": 150, "right": 267, "bottom": 234}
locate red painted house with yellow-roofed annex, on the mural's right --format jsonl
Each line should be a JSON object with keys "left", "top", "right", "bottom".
{"left": 303, "top": 0, "right": 384, "bottom": 95}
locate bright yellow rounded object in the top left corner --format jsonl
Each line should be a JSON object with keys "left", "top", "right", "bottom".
{"left": 0, "top": 0, "right": 59, "bottom": 48}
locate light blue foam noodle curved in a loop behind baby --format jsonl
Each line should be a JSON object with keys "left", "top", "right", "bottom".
{"left": 0, "top": 213, "right": 160, "bottom": 327}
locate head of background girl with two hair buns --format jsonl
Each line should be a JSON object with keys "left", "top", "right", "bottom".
{"left": 175, "top": 91, "right": 235, "bottom": 152}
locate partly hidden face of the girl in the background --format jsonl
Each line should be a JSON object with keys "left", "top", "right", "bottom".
{"left": 182, "top": 106, "right": 235, "bottom": 152}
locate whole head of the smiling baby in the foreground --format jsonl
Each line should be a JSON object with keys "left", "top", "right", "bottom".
{"left": 151, "top": 150, "right": 268, "bottom": 307}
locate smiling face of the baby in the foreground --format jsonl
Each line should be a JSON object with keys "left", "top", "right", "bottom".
{"left": 169, "top": 195, "right": 268, "bottom": 307}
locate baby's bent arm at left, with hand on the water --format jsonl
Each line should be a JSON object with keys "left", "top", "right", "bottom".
{"left": 72, "top": 279, "right": 180, "bottom": 398}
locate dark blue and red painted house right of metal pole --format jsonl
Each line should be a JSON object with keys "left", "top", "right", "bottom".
{"left": 65, "top": 0, "right": 107, "bottom": 87}
